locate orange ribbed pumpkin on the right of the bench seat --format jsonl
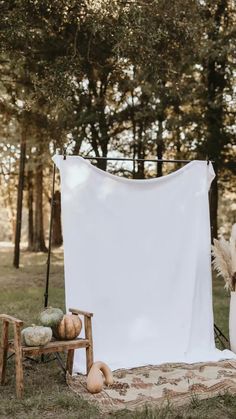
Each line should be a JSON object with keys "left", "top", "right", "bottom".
{"left": 53, "top": 314, "right": 82, "bottom": 340}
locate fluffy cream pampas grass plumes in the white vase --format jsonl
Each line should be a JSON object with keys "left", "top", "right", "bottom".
{"left": 212, "top": 224, "right": 236, "bottom": 291}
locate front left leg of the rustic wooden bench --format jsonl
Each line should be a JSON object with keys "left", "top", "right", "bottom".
{"left": 14, "top": 324, "right": 24, "bottom": 398}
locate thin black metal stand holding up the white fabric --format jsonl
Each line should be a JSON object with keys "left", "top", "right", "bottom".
{"left": 44, "top": 156, "right": 229, "bottom": 348}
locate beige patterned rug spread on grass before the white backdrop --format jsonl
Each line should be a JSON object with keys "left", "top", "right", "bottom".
{"left": 67, "top": 360, "right": 236, "bottom": 413}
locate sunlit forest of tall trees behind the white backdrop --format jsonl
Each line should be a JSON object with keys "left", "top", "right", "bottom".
{"left": 0, "top": 0, "right": 236, "bottom": 262}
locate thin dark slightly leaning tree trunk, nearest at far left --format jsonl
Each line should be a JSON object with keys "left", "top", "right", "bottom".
{"left": 13, "top": 124, "right": 26, "bottom": 268}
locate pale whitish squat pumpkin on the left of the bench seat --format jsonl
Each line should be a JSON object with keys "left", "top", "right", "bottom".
{"left": 21, "top": 326, "right": 52, "bottom": 346}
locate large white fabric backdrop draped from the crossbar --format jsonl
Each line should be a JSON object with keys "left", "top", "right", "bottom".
{"left": 54, "top": 155, "right": 235, "bottom": 370}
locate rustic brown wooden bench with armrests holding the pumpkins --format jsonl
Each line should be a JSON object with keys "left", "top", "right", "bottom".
{"left": 0, "top": 309, "right": 93, "bottom": 398}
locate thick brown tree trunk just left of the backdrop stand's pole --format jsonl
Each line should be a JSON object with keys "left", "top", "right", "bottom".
{"left": 33, "top": 150, "right": 47, "bottom": 252}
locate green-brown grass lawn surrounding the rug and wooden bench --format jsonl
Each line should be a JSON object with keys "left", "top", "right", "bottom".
{"left": 0, "top": 244, "right": 236, "bottom": 419}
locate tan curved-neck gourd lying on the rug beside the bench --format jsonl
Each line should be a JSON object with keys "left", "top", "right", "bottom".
{"left": 87, "top": 361, "right": 114, "bottom": 394}
